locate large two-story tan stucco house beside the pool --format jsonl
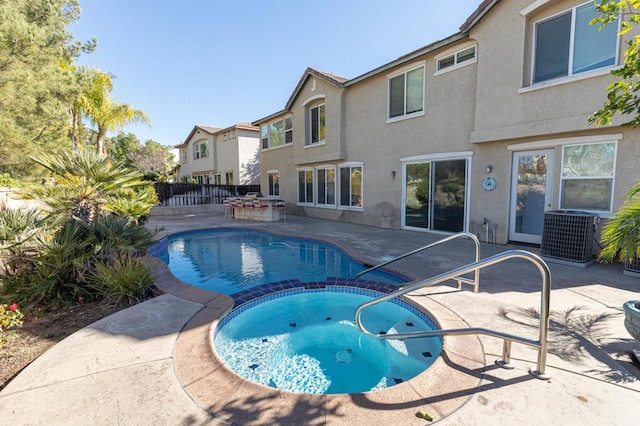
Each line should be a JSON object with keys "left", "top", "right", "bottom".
{"left": 253, "top": 0, "right": 640, "bottom": 244}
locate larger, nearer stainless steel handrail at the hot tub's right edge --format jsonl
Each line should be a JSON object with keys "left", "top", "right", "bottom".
{"left": 355, "top": 250, "right": 551, "bottom": 380}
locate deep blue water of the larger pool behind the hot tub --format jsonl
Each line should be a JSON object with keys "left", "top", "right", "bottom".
{"left": 160, "top": 229, "right": 405, "bottom": 294}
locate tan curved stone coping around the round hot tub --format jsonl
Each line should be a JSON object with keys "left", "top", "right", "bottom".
{"left": 145, "top": 231, "right": 486, "bottom": 424}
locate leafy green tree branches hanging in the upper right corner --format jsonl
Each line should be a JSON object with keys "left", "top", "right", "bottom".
{"left": 589, "top": 0, "right": 640, "bottom": 127}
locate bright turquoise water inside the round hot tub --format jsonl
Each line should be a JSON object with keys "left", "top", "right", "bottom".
{"left": 214, "top": 288, "right": 442, "bottom": 394}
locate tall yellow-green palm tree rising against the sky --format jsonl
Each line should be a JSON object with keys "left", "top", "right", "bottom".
{"left": 78, "top": 70, "right": 151, "bottom": 154}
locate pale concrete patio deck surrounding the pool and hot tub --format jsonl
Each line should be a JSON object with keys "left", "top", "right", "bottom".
{"left": 0, "top": 209, "right": 640, "bottom": 425}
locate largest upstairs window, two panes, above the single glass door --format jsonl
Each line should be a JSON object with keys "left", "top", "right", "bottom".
{"left": 532, "top": 3, "right": 618, "bottom": 83}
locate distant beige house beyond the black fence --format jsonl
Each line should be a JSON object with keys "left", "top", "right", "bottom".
{"left": 176, "top": 124, "right": 260, "bottom": 185}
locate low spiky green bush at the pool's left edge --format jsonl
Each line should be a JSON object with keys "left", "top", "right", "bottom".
{"left": 87, "top": 254, "right": 153, "bottom": 304}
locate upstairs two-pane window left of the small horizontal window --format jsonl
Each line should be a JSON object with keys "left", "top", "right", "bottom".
{"left": 389, "top": 65, "right": 424, "bottom": 118}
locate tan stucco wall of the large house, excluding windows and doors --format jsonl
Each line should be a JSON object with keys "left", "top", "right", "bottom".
{"left": 261, "top": 0, "right": 640, "bottom": 244}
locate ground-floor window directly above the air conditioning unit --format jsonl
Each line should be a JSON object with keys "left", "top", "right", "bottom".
{"left": 560, "top": 142, "right": 616, "bottom": 212}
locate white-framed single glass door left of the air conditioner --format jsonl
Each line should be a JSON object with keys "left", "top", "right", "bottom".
{"left": 509, "top": 149, "right": 554, "bottom": 244}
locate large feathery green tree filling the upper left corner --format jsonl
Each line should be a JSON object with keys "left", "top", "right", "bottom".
{"left": 0, "top": 0, "right": 96, "bottom": 177}
